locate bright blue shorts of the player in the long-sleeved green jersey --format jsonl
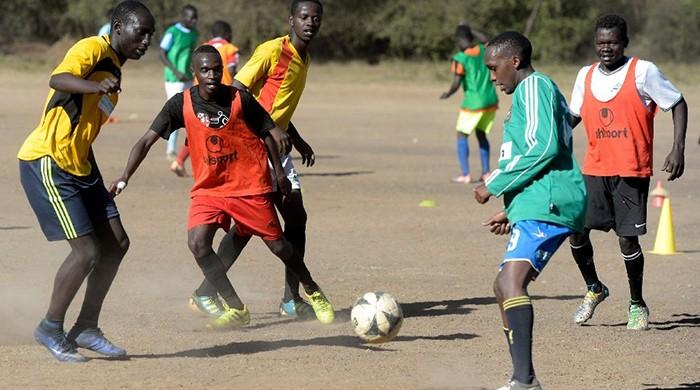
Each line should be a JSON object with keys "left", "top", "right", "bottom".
{"left": 501, "top": 220, "right": 574, "bottom": 272}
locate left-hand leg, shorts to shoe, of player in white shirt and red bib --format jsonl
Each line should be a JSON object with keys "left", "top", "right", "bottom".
{"left": 569, "top": 175, "right": 615, "bottom": 324}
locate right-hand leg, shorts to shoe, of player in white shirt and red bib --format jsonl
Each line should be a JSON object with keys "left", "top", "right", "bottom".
{"left": 614, "top": 177, "right": 650, "bottom": 330}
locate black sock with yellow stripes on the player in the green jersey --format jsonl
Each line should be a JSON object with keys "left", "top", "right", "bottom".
{"left": 503, "top": 295, "right": 535, "bottom": 384}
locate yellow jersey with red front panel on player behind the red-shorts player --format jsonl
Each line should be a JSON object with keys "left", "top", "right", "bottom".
{"left": 235, "top": 35, "right": 311, "bottom": 130}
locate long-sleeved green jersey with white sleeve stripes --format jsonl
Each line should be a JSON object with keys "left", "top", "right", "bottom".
{"left": 486, "top": 72, "right": 586, "bottom": 231}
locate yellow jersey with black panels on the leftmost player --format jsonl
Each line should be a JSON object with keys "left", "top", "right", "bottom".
{"left": 17, "top": 35, "right": 121, "bottom": 176}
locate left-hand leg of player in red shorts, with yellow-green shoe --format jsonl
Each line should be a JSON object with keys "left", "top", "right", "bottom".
{"left": 187, "top": 223, "right": 250, "bottom": 328}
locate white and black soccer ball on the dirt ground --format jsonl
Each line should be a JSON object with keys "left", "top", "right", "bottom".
{"left": 350, "top": 291, "right": 403, "bottom": 343}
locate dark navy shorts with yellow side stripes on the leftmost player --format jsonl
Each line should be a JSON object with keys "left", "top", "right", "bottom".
{"left": 19, "top": 156, "right": 119, "bottom": 241}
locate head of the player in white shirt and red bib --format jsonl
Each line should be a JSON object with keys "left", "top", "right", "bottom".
{"left": 594, "top": 15, "right": 629, "bottom": 66}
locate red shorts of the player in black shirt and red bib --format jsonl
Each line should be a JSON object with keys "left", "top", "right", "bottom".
{"left": 187, "top": 194, "right": 282, "bottom": 241}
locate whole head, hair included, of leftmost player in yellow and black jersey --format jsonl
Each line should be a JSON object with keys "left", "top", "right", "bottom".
{"left": 110, "top": 0, "right": 156, "bottom": 62}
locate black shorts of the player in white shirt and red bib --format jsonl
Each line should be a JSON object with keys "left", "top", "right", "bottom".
{"left": 583, "top": 175, "right": 650, "bottom": 237}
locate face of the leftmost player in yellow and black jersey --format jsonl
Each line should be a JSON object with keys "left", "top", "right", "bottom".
{"left": 113, "top": 13, "right": 156, "bottom": 60}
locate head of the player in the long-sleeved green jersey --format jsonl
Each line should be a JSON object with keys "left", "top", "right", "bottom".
{"left": 484, "top": 31, "right": 532, "bottom": 95}
